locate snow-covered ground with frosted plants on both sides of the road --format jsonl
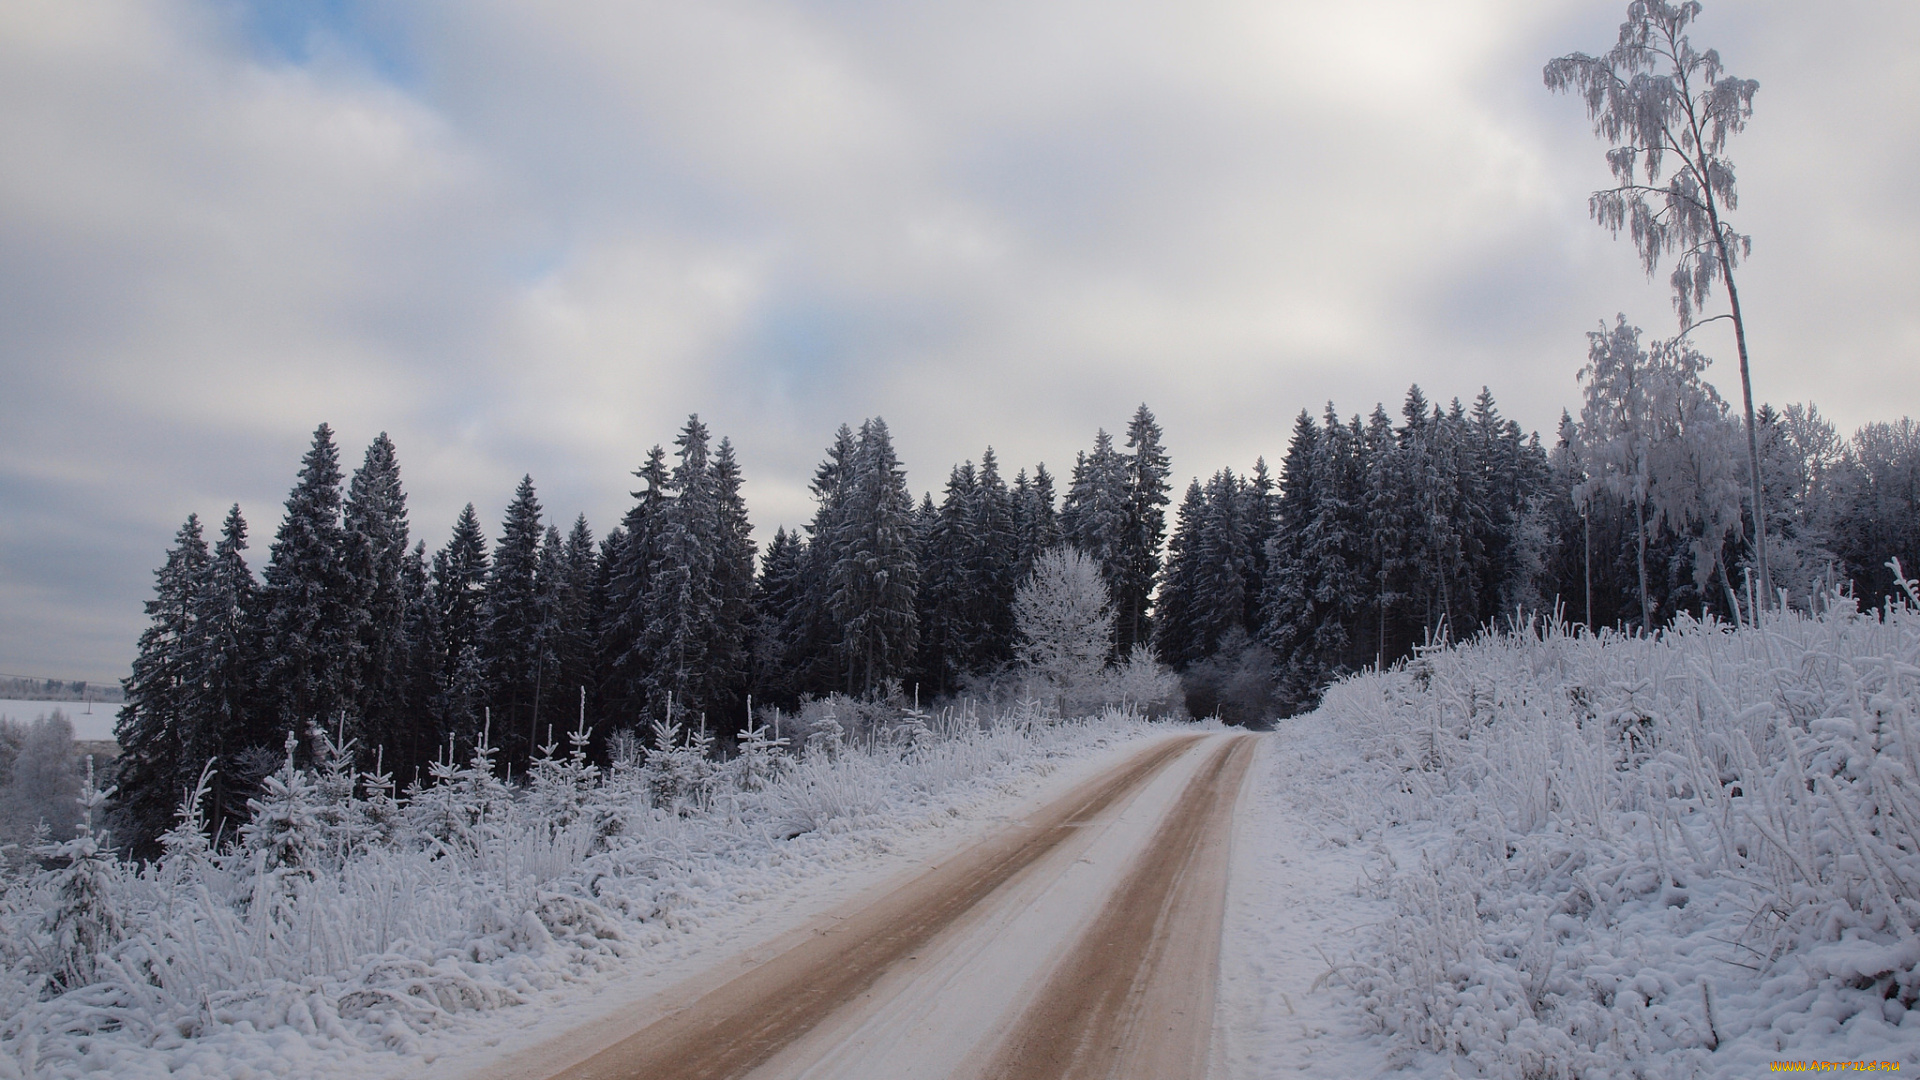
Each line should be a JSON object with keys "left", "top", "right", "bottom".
{"left": 0, "top": 595, "right": 1920, "bottom": 1080}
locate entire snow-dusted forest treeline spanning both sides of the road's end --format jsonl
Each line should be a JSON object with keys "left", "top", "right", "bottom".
{"left": 117, "top": 374, "right": 1920, "bottom": 849}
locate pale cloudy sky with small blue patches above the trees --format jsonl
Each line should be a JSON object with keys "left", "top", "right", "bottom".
{"left": 0, "top": 0, "right": 1920, "bottom": 678}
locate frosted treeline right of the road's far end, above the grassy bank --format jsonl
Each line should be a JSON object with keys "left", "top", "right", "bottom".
{"left": 1154, "top": 365, "right": 1920, "bottom": 721}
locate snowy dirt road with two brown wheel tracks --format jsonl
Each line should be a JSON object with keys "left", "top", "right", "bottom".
{"left": 478, "top": 734, "right": 1254, "bottom": 1080}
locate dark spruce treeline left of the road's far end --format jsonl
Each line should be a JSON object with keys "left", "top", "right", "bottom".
{"left": 113, "top": 405, "right": 1167, "bottom": 851}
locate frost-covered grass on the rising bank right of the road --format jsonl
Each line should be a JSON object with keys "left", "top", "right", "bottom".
{"left": 1317, "top": 591, "right": 1920, "bottom": 1078}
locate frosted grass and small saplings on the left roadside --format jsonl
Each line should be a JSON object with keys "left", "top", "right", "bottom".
{"left": 0, "top": 699, "right": 1146, "bottom": 1078}
